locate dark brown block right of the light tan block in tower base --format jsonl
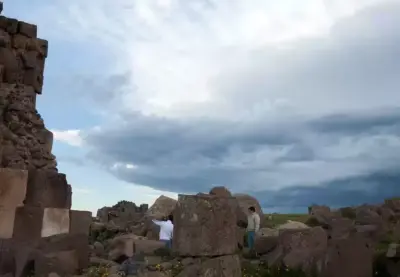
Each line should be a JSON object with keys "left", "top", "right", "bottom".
{"left": 25, "top": 170, "right": 71, "bottom": 209}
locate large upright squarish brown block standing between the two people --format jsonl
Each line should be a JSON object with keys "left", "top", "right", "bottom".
{"left": 173, "top": 195, "right": 237, "bottom": 256}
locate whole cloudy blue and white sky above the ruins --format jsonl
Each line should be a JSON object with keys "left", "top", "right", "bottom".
{"left": 3, "top": 0, "right": 400, "bottom": 212}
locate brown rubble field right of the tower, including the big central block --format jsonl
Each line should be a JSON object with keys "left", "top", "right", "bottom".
{"left": 85, "top": 188, "right": 400, "bottom": 277}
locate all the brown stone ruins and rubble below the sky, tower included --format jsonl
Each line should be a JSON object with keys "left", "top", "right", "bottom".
{"left": 0, "top": 2, "right": 400, "bottom": 277}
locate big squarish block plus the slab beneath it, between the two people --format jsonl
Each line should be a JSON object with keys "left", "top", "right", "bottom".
{"left": 173, "top": 194, "right": 241, "bottom": 277}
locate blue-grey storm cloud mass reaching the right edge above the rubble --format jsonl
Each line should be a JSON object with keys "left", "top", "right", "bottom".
{"left": 86, "top": 1, "right": 400, "bottom": 208}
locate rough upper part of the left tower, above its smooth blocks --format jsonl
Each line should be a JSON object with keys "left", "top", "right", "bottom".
{"left": 0, "top": 2, "right": 57, "bottom": 171}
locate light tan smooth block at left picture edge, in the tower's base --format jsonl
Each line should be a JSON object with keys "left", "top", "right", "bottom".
{"left": 0, "top": 168, "right": 28, "bottom": 208}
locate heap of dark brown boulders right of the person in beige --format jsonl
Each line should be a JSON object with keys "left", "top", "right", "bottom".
{"left": 255, "top": 200, "right": 400, "bottom": 277}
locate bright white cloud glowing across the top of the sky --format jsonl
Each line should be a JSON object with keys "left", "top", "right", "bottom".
{"left": 25, "top": 0, "right": 390, "bottom": 116}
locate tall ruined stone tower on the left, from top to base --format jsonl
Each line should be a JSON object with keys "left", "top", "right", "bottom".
{"left": 0, "top": 3, "right": 92, "bottom": 277}
